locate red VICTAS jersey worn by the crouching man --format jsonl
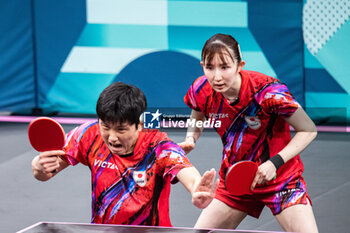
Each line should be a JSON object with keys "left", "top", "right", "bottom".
{"left": 64, "top": 121, "right": 192, "bottom": 226}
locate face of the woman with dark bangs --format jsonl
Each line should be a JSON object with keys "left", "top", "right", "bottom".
{"left": 201, "top": 53, "right": 244, "bottom": 96}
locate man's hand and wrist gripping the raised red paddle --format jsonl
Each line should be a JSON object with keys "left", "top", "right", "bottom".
{"left": 32, "top": 150, "right": 69, "bottom": 181}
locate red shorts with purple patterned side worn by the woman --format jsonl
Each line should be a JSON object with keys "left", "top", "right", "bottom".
{"left": 215, "top": 176, "right": 312, "bottom": 218}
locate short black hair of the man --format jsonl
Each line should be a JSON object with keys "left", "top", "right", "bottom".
{"left": 96, "top": 82, "right": 147, "bottom": 126}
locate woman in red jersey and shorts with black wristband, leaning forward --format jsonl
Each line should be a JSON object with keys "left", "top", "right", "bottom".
{"left": 179, "top": 34, "right": 318, "bottom": 233}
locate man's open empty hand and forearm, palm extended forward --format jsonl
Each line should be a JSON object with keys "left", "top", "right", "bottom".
{"left": 177, "top": 167, "right": 219, "bottom": 209}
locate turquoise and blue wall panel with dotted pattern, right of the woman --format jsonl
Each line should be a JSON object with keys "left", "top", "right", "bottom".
{"left": 303, "top": 0, "right": 350, "bottom": 124}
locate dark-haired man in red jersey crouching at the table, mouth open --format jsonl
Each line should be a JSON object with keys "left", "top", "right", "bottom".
{"left": 32, "top": 82, "right": 218, "bottom": 226}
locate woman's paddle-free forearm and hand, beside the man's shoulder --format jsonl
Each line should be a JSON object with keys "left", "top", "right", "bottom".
{"left": 179, "top": 110, "right": 205, "bottom": 154}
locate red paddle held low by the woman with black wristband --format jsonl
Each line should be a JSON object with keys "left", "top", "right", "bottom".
{"left": 225, "top": 161, "right": 258, "bottom": 196}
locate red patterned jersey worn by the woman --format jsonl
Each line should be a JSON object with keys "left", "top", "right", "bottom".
{"left": 184, "top": 70, "right": 304, "bottom": 193}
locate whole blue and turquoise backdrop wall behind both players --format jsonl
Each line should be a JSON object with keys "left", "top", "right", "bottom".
{"left": 0, "top": 0, "right": 350, "bottom": 123}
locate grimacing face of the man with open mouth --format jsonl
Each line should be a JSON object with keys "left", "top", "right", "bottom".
{"left": 99, "top": 120, "right": 142, "bottom": 155}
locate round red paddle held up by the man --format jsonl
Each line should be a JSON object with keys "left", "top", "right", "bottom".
{"left": 28, "top": 117, "right": 65, "bottom": 152}
